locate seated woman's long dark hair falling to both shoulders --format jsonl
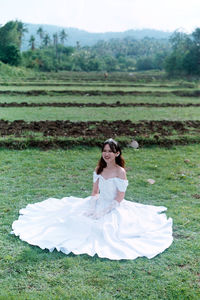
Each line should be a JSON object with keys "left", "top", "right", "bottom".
{"left": 96, "top": 139, "right": 125, "bottom": 174}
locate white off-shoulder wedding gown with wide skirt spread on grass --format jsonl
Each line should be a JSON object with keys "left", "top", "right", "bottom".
{"left": 11, "top": 172, "right": 173, "bottom": 260}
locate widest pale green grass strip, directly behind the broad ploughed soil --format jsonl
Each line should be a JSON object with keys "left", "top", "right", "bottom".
{"left": 0, "top": 107, "right": 200, "bottom": 122}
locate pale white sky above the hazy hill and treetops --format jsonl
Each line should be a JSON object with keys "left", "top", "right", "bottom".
{"left": 0, "top": 0, "right": 200, "bottom": 33}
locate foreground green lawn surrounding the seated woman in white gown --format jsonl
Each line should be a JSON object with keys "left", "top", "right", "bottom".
{"left": 0, "top": 145, "right": 200, "bottom": 300}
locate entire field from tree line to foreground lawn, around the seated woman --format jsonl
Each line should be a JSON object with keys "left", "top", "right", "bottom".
{"left": 0, "top": 72, "right": 200, "bottom": 300}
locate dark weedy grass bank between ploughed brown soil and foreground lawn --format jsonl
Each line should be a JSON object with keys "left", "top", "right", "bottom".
{"left": 0, "top": 131, "right": 200, "bottom": 150}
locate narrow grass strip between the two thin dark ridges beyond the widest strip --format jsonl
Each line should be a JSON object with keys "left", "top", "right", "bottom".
{"left": 0, "top": 95, "right": 200, "bottom": 103}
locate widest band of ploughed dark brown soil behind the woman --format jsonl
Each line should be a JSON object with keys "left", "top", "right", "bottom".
{"left": 0, "top": 120, "right": 200, "bottom": 140}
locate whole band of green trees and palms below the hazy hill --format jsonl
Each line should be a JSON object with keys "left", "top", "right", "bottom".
{"left": 0, "top": 21, "right": 200, "bottom": 75}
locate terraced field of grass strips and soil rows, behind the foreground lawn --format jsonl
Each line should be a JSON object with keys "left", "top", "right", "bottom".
{"left": 0, "top": 73, "right": 200, "bottom": 149}
